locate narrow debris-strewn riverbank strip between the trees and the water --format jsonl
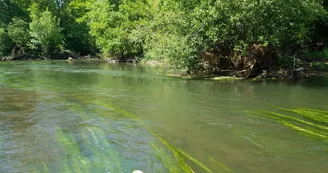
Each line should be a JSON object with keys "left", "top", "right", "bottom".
{"left": 0, "top": 56, "right": 328, "bottom": 81}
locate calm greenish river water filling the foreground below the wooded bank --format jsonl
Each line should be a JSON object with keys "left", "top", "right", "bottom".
{"left": 0, "top": 61, "right": 328, "bottom": 173}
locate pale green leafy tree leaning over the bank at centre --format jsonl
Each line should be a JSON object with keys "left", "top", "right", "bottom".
{"left": 133, "top": 1, "right": 199, "bottom": 70}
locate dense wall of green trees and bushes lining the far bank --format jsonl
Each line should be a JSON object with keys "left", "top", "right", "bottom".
{"left": 0, "top": 0, "right": 328, "bottom": 77}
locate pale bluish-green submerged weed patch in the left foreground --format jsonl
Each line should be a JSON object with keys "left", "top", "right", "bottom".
{"left": 57, "top": 127, "right": 123, "bottom": 173}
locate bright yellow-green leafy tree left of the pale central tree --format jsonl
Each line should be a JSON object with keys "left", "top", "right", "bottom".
{"left": 88, "top": 0, "right": 142, "bottom": 58}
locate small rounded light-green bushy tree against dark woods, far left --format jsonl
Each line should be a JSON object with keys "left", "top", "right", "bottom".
{"left": 30, "top": 10, "right": 63, "bottom": 55}
